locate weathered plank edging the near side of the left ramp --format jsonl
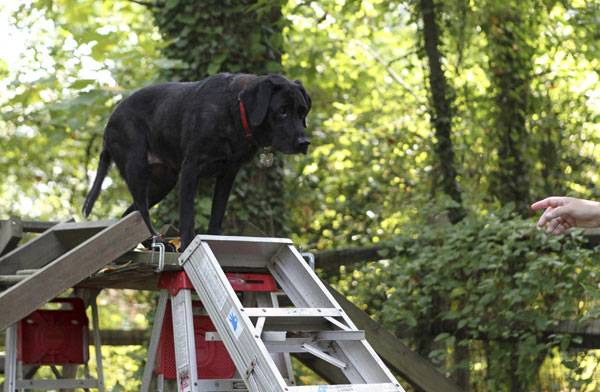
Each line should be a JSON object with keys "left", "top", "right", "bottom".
{"left": 0, "top": 212, "right": 150, "bottom": 331}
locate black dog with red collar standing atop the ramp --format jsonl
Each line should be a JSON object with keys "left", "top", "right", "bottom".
{"left": 82, "top": 73, "right": 311, "bottom": 250}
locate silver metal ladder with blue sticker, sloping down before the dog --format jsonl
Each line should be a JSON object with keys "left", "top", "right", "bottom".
{"left": 157, "top": 235, "right": 404, "bottom": 392}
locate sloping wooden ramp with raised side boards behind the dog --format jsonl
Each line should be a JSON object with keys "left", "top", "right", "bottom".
{"left": 0, "top": 212, "right": 150, "bottom": 331}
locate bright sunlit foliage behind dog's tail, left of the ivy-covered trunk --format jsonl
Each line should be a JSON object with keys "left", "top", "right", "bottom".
{"left": 0, "top": 0, "right": 173, "bottom": 220}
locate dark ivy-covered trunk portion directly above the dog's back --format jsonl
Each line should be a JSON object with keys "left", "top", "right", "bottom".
{"left": 153, "top": 0, "right": 283, "bottom": 81}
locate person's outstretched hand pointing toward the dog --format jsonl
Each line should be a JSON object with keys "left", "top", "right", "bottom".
{"left": 531, "top": 196, "right": 600, "bottom": 234}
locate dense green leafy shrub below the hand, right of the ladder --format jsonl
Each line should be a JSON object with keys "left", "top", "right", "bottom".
{"left": 338, "top": 202, "right": 598, "bottom": 390}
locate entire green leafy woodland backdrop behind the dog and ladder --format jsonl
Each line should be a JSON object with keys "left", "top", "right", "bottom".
{"left": 0, "top": 0, "right": 600, "bottom": 390}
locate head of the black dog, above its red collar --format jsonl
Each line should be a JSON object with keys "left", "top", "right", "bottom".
{"left": 240, "top": 74, "right": 311, "bottom": 154}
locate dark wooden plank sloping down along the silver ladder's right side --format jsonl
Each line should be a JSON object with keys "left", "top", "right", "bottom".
{"left": 326, "top": 283, "right": 462, "bottom": 392}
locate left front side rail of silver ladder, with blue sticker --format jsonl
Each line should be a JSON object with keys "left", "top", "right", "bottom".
{"left": 180, "top": 237, "right": 287, "bottom": 392}
